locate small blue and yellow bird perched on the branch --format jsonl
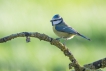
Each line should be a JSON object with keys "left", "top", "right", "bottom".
{"left": 51, "top": 14, "right": 90, "bottom": 40}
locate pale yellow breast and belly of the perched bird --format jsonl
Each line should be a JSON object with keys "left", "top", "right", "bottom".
{"left": 53, "top": 26, "right": 74, "bottom": 39}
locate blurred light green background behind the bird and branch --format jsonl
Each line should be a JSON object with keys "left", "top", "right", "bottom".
{"left": 0, "top": 0, "right": 106, "bottom": 71}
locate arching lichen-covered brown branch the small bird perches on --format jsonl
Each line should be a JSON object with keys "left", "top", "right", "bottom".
{"left": 0, "top": 32, "right": 106, "bottom": 71}
